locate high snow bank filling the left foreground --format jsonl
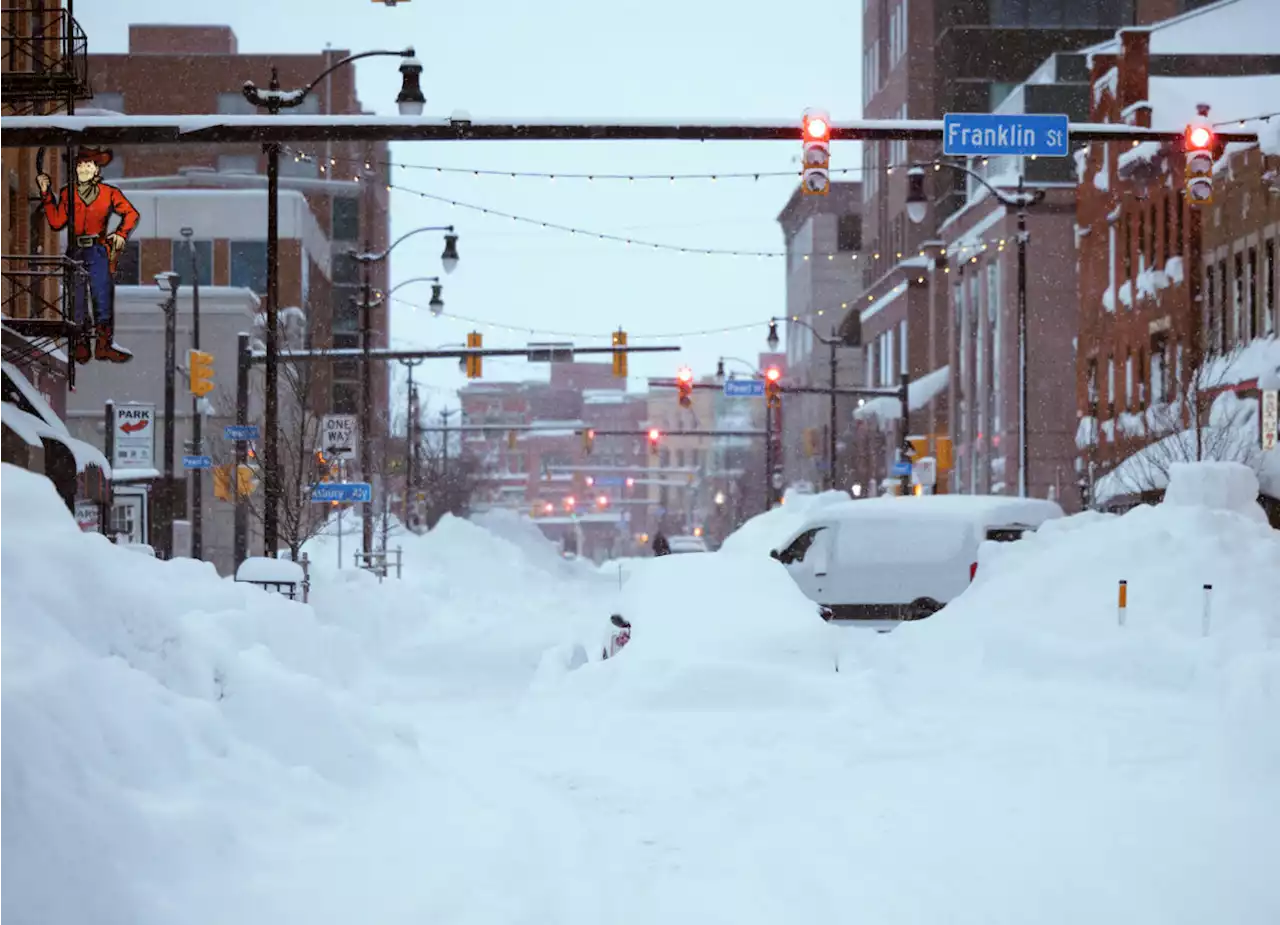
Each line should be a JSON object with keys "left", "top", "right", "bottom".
{"left": 0, "top": 464, "right": 416, "bottom": 925}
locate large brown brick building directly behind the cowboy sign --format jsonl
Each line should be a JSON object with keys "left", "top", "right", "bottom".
{"left": 90, "top": 24, "right": 390, "bottom": 427}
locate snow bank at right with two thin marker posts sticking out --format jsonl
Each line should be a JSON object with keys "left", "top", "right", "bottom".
{"left": 890, "top": 463, "right": 1280, "bottom": 711}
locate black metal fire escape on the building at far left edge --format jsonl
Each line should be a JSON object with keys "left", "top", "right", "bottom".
{"left": 0, "top": 0, "right": 93, "bottom": 389}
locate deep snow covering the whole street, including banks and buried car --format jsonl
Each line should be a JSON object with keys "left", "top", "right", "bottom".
{"left": 0, "top": 466, "right": 1280, "bottom": 925}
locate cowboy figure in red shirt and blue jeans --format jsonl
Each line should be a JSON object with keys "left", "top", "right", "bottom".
{"left": 36, "top": 147, "right": 138, "bottom": 363}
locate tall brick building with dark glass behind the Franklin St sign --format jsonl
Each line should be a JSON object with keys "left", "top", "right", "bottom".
{"left": 844, "top": 0, "right": 1199, "bottom": 490}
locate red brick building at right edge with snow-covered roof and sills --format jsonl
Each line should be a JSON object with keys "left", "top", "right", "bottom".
{"left": 1075, "top": 0, "right": 1280, "bottom": 503}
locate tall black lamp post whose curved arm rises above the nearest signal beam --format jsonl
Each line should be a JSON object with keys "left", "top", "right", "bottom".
{"left": 242, "top": 49, "right": 426, "bottom": 558}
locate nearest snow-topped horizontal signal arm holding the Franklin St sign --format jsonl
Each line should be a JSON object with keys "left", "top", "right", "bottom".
{"left": 0, "top": 114, "right": 1258, "bottom": 147}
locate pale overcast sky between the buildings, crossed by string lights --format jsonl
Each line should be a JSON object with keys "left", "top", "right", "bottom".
{"left": 76, "top": 0, "right": 861, "bottom": 408}
